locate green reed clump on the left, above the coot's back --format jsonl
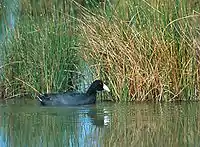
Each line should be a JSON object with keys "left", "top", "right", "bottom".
{"left": 2, "top": 1, "right": 79, "bottom": 98}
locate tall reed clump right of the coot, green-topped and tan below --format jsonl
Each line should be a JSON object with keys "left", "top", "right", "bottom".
{"left": 80, "top": 0, "right": 200, "bottom": 101}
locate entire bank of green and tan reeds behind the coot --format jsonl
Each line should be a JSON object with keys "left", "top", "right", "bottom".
{"left": 0, "top": 0, "right": 200, "bottom": 101}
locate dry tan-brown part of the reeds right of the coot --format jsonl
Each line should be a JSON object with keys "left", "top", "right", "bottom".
{"left": 81, "top": 10, "right": 199, "bottom": 101}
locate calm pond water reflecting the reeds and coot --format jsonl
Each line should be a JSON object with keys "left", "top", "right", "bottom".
{"left": 0, "top": 103, "right": 200, "bottom": 147}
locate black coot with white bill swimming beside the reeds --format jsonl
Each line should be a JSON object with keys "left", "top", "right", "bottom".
{"left": 37, "top": 80, "right": 110, "bottom": 106}
